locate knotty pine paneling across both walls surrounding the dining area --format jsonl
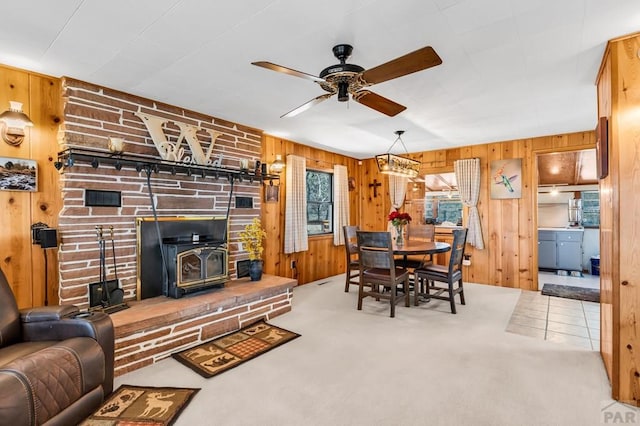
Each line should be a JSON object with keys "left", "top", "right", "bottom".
{"left": 262, "top": 131, "right": 595, "bottom": 290}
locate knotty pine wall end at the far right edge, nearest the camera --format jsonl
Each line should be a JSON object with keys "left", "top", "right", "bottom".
{"left": 598, "top": 34, "right": 640, "bottom": 405}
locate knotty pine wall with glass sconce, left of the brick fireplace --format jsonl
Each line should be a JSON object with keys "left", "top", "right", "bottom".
{"left": 0, "top": 65, "right": 61, "bottom": 308}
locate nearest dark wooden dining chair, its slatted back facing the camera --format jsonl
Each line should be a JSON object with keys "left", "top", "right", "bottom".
{"left": 356, "top": 231, "right": 410, "bottom": 318}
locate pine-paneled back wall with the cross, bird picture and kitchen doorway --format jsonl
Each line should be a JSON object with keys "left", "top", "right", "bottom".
{"left": 360, "top": 131, "right": 595, "bottom": 290}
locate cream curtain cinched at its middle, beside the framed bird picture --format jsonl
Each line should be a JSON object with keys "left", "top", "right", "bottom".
{"left": 453, "top": 158, "right": 484, "bottom": 250}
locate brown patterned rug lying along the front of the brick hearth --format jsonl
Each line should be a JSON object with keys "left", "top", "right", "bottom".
{"left": 173, "top": 321, "right": 300, "bottom": 377}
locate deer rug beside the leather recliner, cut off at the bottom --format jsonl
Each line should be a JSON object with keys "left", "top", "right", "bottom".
{"left": 80, "top": 385, "right": 199, "bottom": 426}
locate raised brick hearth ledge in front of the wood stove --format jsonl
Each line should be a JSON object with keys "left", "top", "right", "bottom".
{"left": 111, "top": 275, "right": 296, "bottom": 376}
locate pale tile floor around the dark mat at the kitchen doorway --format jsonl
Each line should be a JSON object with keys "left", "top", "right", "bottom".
{"left": 506, "top": 273, "right": 600, "bottom": 351}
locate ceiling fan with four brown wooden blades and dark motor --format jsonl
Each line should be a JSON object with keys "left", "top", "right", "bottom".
{"left": 252, "top": 44, "right": 442, "bottom": 118}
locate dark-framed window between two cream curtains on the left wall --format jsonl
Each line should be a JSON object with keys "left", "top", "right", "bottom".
{"left": 307, "top": 170, "right": 333, "bottom": 235}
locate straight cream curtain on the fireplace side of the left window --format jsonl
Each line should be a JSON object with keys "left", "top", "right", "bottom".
{"left": 284, "top": 155, "right": 309, "bottom": 253}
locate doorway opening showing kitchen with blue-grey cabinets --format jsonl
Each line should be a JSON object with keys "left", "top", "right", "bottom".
{"left": 535, "top": 149, "right": 600, "bottom": 290}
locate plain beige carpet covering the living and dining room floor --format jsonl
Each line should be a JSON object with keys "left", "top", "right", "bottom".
{"left": 116, "top": 275, "right": 612, "bottom": 425}
